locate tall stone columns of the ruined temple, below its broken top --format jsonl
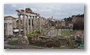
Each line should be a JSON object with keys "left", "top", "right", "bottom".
{"left": 18, "top": 15, "right": 41, "bottom": 35}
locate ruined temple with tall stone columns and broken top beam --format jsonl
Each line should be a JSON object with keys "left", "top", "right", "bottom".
{"left": 16, "top": 8, "right": 41, "bottom": 44}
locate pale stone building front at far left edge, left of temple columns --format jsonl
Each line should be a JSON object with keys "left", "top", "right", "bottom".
{"left": 4, "top": 17, "right": 13, "bottom": 36}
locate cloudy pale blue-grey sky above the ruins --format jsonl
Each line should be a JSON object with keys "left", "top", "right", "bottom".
{"left": 4, "top": 3, "right": 84, "bottom": 20}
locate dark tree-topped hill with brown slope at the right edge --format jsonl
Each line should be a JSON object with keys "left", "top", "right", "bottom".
{"left": 64, "top": 14, "right": 84, "bottom": 30}
